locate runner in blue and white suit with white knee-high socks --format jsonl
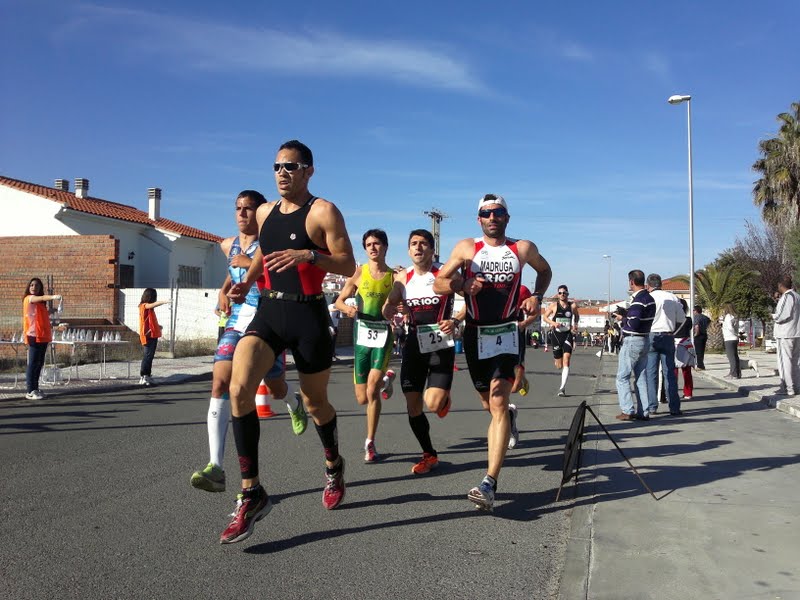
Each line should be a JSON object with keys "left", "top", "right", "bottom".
{"left": 190, "top": 190, "right": 307, "bottom": 492}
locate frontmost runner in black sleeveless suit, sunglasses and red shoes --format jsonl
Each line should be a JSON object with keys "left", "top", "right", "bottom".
{"left": 220, "top": 140, "right": 356, "bottom": 544}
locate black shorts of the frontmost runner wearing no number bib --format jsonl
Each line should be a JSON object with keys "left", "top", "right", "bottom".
{"left": 245, "top": 298, "right": 333, "bottom": 375}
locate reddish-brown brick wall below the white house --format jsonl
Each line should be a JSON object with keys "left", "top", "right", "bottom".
{"left": 0, "top": 235, "right": 119, "bottom": 338}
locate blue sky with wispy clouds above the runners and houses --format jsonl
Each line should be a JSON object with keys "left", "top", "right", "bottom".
{"left": 0, "top": 0, "right": 800, "bottom": 298}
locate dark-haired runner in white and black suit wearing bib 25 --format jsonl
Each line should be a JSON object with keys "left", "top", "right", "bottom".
{"left": 383, "top": 229, "right": 459, "bottom": 475}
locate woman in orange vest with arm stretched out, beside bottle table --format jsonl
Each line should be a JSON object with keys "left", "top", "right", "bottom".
{"left": 22, "top": 277, "right": 61, "bottom": 400}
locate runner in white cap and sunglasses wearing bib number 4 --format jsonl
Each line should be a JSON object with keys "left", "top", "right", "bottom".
{"left": 433, "top": 194, "right": 553, "bottom": 510}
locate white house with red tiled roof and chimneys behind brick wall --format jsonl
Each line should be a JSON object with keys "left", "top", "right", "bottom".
{"left": 0, "top": 176, "right": 226, "bottom": 288}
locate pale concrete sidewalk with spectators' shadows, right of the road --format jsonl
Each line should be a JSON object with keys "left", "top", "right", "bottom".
{"left": 559, "top": 353, "right": 800, "bottom": 600}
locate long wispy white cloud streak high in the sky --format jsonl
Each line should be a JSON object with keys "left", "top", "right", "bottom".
{"left": 57, "top": 6, "right": 484, "bottom": 93}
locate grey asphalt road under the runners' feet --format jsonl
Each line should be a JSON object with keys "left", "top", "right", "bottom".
{"left": 0, "top": 350, "right": 598, "bottom": 600}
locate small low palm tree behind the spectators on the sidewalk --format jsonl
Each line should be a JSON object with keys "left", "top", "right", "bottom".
{"left": 672, "top": 264, "right": 755, "bottom": 350}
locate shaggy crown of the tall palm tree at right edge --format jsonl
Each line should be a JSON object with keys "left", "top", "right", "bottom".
{"left": 753, "top": 102, "right": 800, "bottom": 224}
